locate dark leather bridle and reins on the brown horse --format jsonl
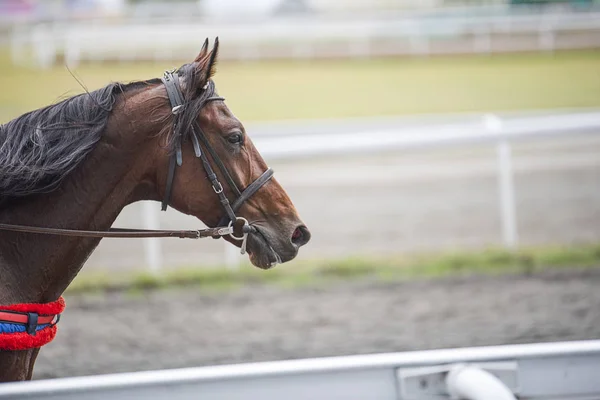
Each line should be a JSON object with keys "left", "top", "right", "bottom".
{"left": 0, "top": 71, "right": 273, "bottom": 250}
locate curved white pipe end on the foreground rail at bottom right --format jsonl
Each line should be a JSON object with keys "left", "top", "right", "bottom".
{"left": 446, "top": 364, "right": 516, "bottom": 400}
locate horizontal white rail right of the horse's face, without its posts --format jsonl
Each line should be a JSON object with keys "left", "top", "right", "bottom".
{"left": 251, "top": 110, "right": 600, "bottom": 160}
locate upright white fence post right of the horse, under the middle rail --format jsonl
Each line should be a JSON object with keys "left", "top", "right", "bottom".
{"left": 484, "top": 114, "right": 519, "bottom": 250}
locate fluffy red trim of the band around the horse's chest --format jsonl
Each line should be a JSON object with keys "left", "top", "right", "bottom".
{"left": 0, "top": 296, "right": 65, "bottom": 350}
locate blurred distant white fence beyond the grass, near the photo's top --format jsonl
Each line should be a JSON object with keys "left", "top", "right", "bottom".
{"left": 10, "top": 7, "right": 600, "bottom": 68}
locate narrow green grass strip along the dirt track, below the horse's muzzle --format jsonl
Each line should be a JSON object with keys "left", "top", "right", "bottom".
{"left": 67, "top": 244, "right": 600, "bottom": 293}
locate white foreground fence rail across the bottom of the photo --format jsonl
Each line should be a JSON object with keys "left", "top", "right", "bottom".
{"left": 0, "top": 340, "right": 600, "bottom": 400}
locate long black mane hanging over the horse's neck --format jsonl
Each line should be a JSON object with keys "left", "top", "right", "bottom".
{"left": 0, "top": 79, "right": 160, "bottom": 203}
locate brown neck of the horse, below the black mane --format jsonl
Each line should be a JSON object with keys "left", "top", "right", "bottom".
{"left": 0, "top": 85, "right": 160, "bottom": 304}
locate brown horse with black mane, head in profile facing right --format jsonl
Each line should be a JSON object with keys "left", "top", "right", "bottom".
{"left": 0, "top": 40, "right": 310, "bottom": 382}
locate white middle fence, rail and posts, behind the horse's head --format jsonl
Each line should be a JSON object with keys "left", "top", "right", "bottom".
{"left": 139, "top": 110, "right": 600, "bottom": 272}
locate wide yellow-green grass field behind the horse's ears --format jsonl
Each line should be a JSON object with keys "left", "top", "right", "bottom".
{"left": 0, "top": 49, "right": 600, "bottom": 122}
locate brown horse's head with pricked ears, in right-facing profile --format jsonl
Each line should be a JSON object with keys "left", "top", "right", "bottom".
{"left": 154, "top": 39, "right": 310, "bottom": 269}
